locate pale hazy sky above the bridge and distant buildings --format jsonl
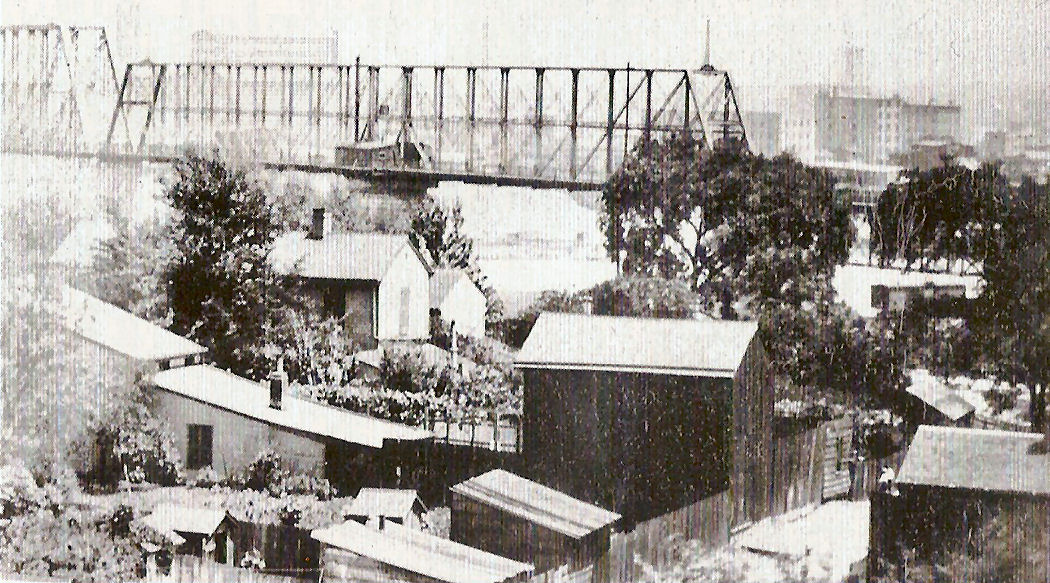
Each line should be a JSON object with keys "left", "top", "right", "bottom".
{"left": 0, "top": 0, "right": 1050, "bottom": 134}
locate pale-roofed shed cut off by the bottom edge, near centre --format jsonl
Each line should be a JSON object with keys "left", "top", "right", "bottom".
{"left": 311, "top": 520, "right": 532, "bottom": 583}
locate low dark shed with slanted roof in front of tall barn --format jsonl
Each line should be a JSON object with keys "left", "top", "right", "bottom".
{"left": 452, "top": 470, "right": 620, "bottom": 582}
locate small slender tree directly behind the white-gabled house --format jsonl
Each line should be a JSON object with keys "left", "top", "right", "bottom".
{"left": 408, "top": 195, "right": 503, "bottom": 324}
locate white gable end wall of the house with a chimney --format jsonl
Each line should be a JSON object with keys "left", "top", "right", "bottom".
{"left": 377, "top": 246, "right": 431, "bottom": 340}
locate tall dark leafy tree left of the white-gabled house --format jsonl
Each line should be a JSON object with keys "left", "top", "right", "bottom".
{"left": 165, "top": 153, "right": 284, "bottom": 376}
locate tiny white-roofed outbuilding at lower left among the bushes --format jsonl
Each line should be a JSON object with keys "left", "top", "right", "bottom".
{"left": 142, "top": 504, "right": 235, "bottom": 565}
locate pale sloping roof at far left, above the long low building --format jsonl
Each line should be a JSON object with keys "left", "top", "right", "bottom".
{"left": 58, "top": 286, "right": 207, "bottom": 360}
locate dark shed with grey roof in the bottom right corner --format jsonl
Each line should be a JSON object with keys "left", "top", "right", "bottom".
{"left": 869, "top": 425, "right": 1050, "bottom": 581}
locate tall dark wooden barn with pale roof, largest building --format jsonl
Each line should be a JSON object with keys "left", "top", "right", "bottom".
{"left": 516, "top": 313, "right": 774, "bottom": 528}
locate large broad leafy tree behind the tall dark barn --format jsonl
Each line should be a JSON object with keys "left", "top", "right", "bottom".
{"left": 602, "top": 134, "right": 854, "bottom": 317}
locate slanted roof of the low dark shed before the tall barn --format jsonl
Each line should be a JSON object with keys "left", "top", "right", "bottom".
{"left": 452, "top": 470, "right": 621, "bottom": 539}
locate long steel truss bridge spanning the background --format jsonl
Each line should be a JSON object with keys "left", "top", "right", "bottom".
{"left": 2, "top": 24, "right": 747, "bottom": 189}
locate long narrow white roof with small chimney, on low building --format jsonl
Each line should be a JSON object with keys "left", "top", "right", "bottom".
{"left": 153, "top": 365, "right": 432, "bottom": 447}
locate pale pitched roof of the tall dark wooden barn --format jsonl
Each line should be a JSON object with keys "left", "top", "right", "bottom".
{"left": 515, "top": 312, "right": 758, "bottom": 377}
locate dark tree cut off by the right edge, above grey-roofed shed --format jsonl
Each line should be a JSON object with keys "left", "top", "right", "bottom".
{"left": 970, "top": 179, "right": 1050, "bottom": 430}
